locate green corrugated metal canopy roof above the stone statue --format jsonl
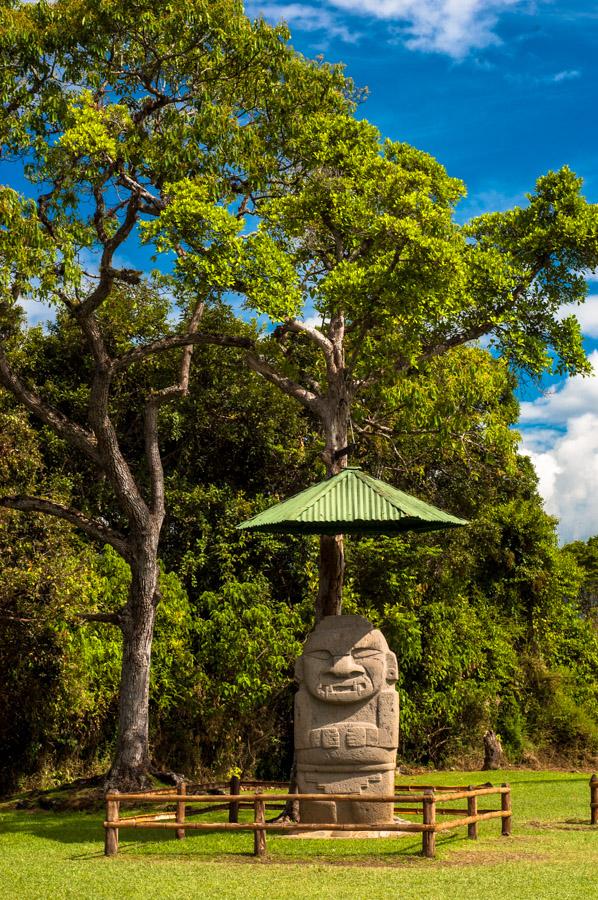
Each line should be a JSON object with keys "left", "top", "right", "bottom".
{"left": 238, "top": 468, "right": 468, "bottom": 534}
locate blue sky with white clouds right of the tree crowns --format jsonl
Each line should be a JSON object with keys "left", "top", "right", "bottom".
{"left": 246, "top": 0, "right": 598, "bottom": 541}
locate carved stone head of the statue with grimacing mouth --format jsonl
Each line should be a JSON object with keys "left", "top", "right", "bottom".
{"left": 295, "top": 616, "right": 397, "bottom": 703}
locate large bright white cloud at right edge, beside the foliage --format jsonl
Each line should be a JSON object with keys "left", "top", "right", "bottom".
{"left": 520, "top": 351, "right": 598, "bottom": 542}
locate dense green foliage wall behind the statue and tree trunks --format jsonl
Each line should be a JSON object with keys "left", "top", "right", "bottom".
{"left": 0, "top": 327, "right": 598, "bottom": 789}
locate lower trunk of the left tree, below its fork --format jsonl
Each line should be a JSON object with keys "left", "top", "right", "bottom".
{"left": 107, "top": 541, "right": 158, "bottom": 790}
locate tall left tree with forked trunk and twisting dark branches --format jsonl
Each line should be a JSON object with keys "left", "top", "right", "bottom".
{"left": 0, "top": 0, "right": 350, "bottom": 785}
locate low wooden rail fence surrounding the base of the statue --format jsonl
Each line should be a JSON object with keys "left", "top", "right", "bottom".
{"left": 104, "top": 779, "right": 511, "bottom": 858}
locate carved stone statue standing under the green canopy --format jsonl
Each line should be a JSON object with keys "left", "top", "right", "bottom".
{"left": 295, "top": 616, "right": 399, "bottom": 824}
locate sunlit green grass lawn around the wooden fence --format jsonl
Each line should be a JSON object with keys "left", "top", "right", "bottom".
{"left": 0, "top": 771, "right": 598, "bottom": 900}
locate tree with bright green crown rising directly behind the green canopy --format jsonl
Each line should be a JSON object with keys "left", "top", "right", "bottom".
{"left": 153, "top": 113, "right": 598, "bottom": 618}
